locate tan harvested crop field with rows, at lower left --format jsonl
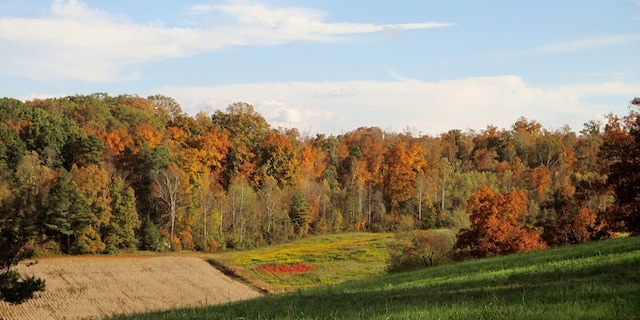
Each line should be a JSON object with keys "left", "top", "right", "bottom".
{"left": 0, "top": 257, "right": 260, "bottom": 320}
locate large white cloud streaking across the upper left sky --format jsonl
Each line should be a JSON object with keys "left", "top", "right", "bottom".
{"left": 0, "top": 0, "right": 448, "bottom": 82}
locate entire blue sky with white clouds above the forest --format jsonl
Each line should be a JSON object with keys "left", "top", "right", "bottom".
{"left": 0, "top": 0, "right": 640, "bottom": 135}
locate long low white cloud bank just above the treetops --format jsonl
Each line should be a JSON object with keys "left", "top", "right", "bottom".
{"left": 159, "top": 76, "right": 640, "bottom": 134}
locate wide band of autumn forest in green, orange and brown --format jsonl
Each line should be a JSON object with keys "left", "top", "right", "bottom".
{"left": 0, "top": 93, "right": 640, "bottom": 257}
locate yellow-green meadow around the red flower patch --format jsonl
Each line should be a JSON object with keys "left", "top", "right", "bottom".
{"left": 202, "top": 232, "right": 393, "bottom": 293}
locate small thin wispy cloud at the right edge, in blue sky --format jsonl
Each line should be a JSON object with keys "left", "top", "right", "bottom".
{"left": 536, "top": 34, "right": 640, "bottom": 54}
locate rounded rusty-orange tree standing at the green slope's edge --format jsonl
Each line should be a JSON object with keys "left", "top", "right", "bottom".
{"left": 454, "top": 187, "right": 547, "bottom": 258}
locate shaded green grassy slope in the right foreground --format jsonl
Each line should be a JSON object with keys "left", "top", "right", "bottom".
{"left": 110, "top": 237, "right": 640, "bottom": 319}
